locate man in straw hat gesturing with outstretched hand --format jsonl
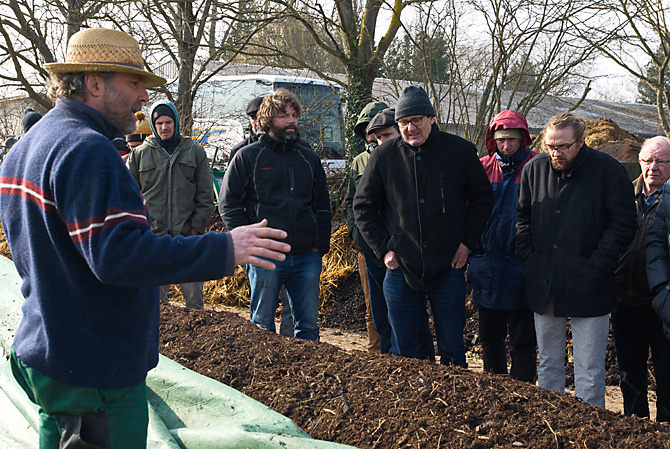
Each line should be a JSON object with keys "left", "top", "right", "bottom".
{"left": 0, "top": 28, "right": 290, "bottom": 448}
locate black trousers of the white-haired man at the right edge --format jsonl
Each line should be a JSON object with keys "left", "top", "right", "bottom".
{"left": 612, "top": 303, "right": 670, "bottom": 422}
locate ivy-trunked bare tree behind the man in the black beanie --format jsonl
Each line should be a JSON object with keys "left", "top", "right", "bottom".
{"left": 240, "top": 0, "right": 421, "bottom": 160}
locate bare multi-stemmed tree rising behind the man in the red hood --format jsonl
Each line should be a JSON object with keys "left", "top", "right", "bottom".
{"left": 470, "top": 0, "right": 608, "bottom": 147}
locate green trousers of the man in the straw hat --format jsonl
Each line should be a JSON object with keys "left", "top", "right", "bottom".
{"left": 10, "top": 349, "right": 149, "bottom": 449}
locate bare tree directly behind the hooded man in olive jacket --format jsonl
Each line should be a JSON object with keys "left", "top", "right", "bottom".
{"left": 107, "top": 0, "right": 272, "bottom": 133}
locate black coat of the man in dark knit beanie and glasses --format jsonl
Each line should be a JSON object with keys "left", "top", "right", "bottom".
{"left": 354, "top": 125, "right": 493, "bottom": 292}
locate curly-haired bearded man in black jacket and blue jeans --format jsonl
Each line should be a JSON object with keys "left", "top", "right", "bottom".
{"left": 219, "top": 89, "right": 330, "bottom": 340}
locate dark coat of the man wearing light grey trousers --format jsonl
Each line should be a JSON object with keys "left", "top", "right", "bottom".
{"left": 516, "top": 145, "right": 637, "bottom": 317}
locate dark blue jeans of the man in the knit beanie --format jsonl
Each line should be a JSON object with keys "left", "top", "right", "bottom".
{"left": 384, "top": 269, "right": 467, "bottom": 367}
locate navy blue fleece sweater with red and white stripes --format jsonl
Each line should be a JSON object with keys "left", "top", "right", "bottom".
{"left": 0, "top": 99, "right": 234, "bottom": 388}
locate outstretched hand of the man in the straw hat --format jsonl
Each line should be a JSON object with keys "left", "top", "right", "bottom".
{"left": 230, "top": 219, "right": 291, "bottom": 270}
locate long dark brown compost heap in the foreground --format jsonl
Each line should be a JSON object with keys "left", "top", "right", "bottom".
{"left": 161, "top": 304, "right": 670, "bottom": 448}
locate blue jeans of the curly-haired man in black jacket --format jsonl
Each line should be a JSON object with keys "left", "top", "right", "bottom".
{"left": 247, "top": 251, "right": 321, "bottom": 341}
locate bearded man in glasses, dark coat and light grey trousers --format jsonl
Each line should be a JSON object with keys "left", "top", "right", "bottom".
{"left": 516, "top": 113, "right": 637, "bottom": 407}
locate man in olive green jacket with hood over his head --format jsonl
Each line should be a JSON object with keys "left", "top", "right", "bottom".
{"left": 127, "top": 101, "right": 214, "bottom": 309}
